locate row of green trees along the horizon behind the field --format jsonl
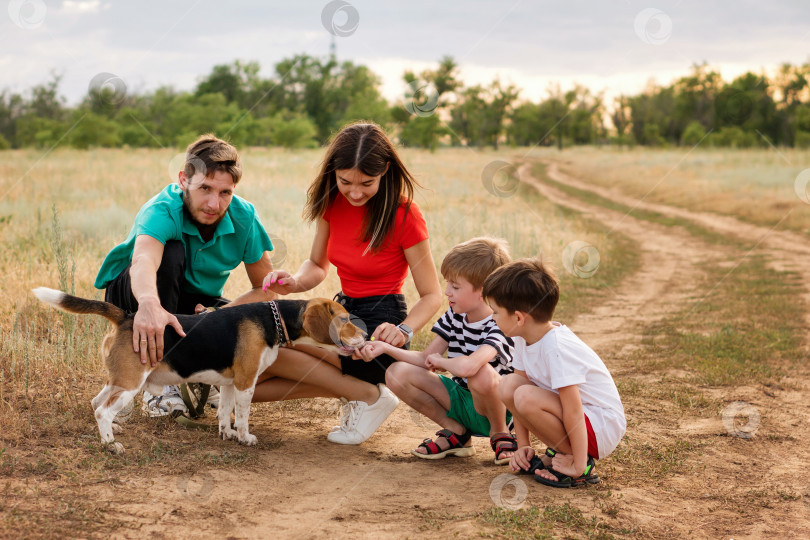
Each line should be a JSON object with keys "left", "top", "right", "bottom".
{"left": 0, "top": 54, "right": 810, "bottom": 149}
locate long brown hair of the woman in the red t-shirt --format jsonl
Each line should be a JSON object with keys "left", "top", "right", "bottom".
{"left": 304, "top": 122, "right": 421, "bottom": 252}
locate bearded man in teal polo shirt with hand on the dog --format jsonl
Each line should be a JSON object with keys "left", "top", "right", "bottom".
{"left": 95, "top": 134, "right": 275, "bottom": 380}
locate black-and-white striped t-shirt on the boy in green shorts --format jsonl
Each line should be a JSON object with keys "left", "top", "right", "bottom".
{"left": 432, "top": 308, "right": 515, "bottom": 388}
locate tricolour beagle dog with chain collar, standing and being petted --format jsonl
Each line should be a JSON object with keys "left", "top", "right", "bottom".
{"left": 33, "top": 287, "right": 365, "bottom": 454}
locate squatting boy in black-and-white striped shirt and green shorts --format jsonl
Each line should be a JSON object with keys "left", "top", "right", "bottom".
{"left": 359, "top": 237, "right": 517, "bottom": 465}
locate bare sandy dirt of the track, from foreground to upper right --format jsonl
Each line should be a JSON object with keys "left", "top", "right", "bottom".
{"left": 7, "top": 163, "right": 810, "bottom": 539}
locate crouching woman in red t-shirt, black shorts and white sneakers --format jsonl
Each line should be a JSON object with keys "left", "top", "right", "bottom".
{"left": 253, "top": 123, "right": 441, "bottom": 444}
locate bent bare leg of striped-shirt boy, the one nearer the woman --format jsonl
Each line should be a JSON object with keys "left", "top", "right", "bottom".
{"left": 385, "top": 362, "right": 470, "bottom": 454}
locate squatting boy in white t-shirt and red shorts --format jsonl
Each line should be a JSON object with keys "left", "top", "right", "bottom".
{"left": 483, "top": 259, "right": 627, "bottom": 487}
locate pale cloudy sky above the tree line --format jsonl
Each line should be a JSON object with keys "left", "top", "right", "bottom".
{"left": 0, "top": 0, "right": 810, "bottom": 108}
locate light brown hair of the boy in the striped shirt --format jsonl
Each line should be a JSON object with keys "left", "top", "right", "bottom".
{"left": 441, "top": 236, "right": 512, "bottom": 289}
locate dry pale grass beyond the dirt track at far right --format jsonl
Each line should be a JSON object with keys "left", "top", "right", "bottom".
{"left": 540, "top": 147, "right": 810, "bottom": 234}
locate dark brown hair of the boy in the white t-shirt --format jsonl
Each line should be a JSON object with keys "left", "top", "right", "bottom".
{"left": 483, "top": 259, "right": 560, "bottom": 322}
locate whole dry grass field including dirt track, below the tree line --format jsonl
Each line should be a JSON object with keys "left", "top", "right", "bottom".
{"left": 0, "top": 149, "right": 810, "bottom": 538}
